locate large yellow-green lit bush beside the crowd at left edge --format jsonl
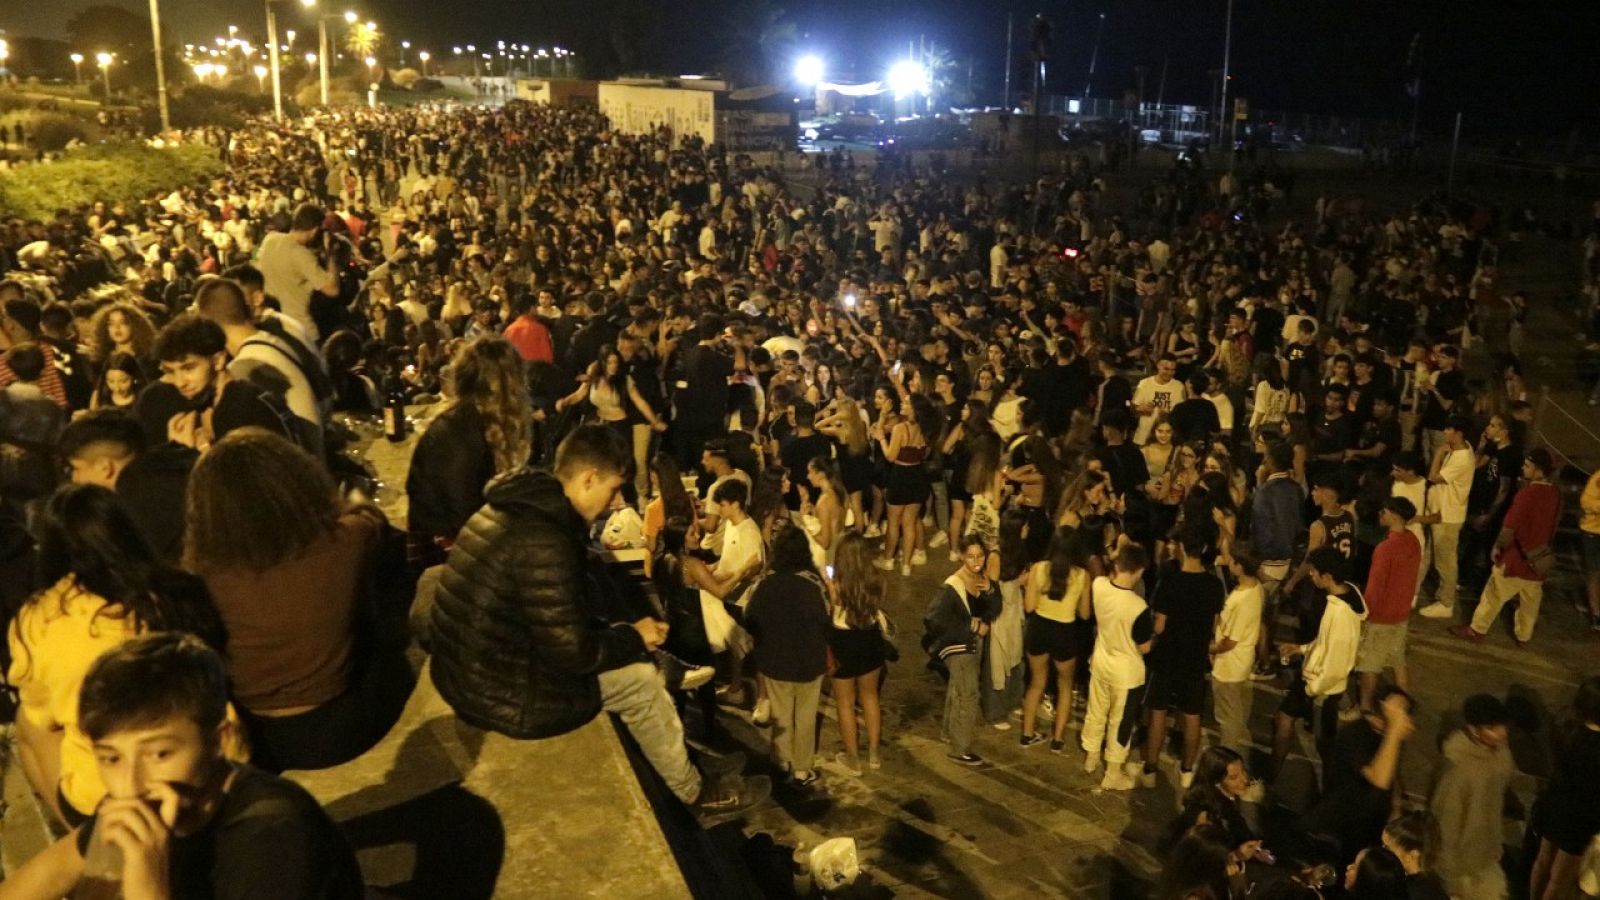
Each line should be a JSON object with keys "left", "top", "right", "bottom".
{"left": 0, "top": 144, "right": 222, "bottom": 219}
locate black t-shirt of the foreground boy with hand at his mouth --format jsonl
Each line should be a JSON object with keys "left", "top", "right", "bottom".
{"left": 78, "top": 765, "right": 365, "bottom": 900}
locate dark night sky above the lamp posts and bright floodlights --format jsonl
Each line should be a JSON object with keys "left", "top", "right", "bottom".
{"left": 0, "top": 0, "right": 1600, "bottom": 136}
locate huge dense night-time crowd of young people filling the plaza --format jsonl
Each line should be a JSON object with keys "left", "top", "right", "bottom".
{"left": 0, "top": 92, "right": 1600, "bottom": 900}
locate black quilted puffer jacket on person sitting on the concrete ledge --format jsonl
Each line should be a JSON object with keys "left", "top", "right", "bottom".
{"left": 432, "top": 469, "right": 645, "bottom": 738}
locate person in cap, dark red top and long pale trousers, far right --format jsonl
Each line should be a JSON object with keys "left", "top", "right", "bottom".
{"left": 1451, "top": 447, "right": 1562, "bottom": 647}
